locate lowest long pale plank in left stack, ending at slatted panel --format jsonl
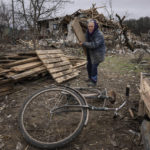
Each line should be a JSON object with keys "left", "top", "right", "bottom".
{"left": 11, "top": 65, "right": 46, "bottom": 80}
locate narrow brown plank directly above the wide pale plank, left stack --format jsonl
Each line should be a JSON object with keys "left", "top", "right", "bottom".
{"left": 4, "top": 57, "right": 40, "bottom": 67}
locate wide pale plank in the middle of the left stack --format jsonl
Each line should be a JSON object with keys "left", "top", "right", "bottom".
{"left": 11, "top": 62, "right": 42, "bottom": 72}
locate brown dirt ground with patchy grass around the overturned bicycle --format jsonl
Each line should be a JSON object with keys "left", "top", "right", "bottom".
{"left": 0, "top": 50, "right": 147, "bottom": 150}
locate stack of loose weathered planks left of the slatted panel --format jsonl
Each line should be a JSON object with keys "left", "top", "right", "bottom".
{"left": 0, "top": 52, "right": 46, "bottom": 96}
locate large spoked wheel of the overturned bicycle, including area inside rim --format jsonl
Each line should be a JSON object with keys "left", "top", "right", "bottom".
{"left": 19, "top": 87, "right": 87, "bottom": 149}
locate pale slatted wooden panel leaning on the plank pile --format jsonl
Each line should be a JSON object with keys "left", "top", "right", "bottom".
{"left": 36, "top": 49, "right": 79, "bottom": 83}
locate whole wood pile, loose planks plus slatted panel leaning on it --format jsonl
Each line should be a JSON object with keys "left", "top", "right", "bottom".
{"left": 0, "top": 49, "right": 86, "bottom": 96}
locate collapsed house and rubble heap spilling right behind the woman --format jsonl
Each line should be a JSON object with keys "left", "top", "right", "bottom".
{"left": 38, "top": 5, "right": 149, "bottom": 51}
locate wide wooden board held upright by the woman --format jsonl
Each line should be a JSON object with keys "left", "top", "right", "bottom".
{"left": 72, "top": 17, "right": 86, "bottom": 54}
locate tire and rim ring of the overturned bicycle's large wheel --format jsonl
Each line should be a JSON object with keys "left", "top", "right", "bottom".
{"left": 19, "top": 86, "right": 87, "bottom": 149}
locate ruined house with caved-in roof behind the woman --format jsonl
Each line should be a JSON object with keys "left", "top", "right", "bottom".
{"left": 38, "top": 5, "right": 137, "bottom": 49}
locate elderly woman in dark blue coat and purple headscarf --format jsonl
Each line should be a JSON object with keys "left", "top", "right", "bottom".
{"left": 80, "top": 20, "right": 105, "bottom": 86}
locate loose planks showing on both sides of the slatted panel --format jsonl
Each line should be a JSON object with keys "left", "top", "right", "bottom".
{"left": 0, "top": 51, "right": 86, "bottom": 96}
